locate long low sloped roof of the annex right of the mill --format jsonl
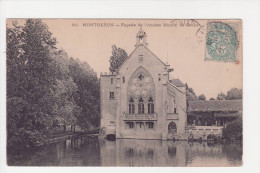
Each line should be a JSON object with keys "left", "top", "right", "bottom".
{"left": 188, "top": 100, "right": 243, "bottom": 112}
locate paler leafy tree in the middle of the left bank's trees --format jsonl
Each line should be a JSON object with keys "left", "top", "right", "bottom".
{"left": 51, "top": 50, "right": 79, "bottom": 125}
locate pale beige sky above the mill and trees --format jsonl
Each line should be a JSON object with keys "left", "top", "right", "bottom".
{"left": 7, "top": 19, "right": 243, "bottom": 99}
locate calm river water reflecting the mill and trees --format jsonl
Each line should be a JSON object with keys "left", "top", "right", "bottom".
{"left": 8, "top": 137, "right": 242, "bottom": 167}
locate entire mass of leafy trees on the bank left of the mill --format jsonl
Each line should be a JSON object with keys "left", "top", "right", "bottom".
{"left": 6, "top": 19, "right": 100, "bottom": 148}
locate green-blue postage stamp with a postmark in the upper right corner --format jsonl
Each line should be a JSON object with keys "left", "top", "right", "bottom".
{"left": 205, "top": 20, "right": 242, "bottom": 62}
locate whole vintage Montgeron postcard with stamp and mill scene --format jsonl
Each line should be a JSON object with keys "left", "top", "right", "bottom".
{"left": 6, "top": 18, "right": 243, "bottom": 167}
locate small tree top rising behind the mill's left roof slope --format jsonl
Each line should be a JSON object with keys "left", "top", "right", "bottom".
{"left": 109, "top": 45, "right": 128, "bottom": 72}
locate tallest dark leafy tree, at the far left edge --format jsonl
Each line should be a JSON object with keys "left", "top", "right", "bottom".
{"left": 7, "top": 19, "right": 57, "bottom": 146}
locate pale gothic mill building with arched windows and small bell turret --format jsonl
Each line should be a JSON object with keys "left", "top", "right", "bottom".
{"left": 100, "top": 28, "right": 187, "bottom": 140}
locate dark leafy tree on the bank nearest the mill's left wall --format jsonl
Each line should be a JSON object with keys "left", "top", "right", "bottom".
{"left": 69, "top": 58, "right": 100, "bottom": 129}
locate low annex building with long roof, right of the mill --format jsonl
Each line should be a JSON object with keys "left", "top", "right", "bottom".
{"left": 186, "top": 100, "right": 243, "bottom": 138}
